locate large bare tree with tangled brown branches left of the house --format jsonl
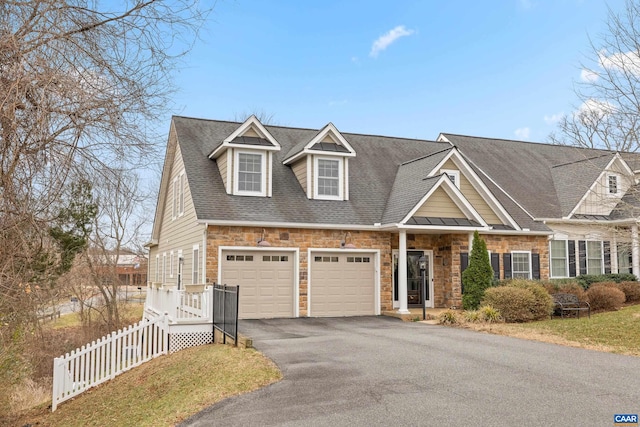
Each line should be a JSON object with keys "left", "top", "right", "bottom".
{"left": 0, "top": 0, "right": 208, "bottom": 336}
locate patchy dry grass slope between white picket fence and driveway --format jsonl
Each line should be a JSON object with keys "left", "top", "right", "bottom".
{"left": 6, "top": 345, "right": 282, "bottom": 427}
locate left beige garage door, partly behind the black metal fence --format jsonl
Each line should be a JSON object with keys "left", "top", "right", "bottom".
{"left": 221, "top": 250, "right": 295, "bottom": 319}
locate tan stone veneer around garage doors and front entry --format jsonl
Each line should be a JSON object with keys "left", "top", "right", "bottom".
{"left": 206, "top": 225, "right": 549, "bottom": 316}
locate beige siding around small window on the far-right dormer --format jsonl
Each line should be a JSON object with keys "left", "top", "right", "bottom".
{"left": 576, "top": 161, "right": 633, "bottom": 215}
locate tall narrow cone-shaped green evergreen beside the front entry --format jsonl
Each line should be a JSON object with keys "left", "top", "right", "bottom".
{"left": 462, "top": 231, "right": 493, "bottom": 310}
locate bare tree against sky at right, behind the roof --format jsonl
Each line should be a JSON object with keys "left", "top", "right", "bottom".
{"left": 550, "top": 0, "right": 640, "bottom": 152}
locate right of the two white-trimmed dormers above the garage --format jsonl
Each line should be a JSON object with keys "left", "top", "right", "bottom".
{"left": 283, "top": 123, "right": 356, "bottom": 200}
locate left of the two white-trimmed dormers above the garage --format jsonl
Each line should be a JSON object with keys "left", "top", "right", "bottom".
{"left": 209, "top": 116, "right": 280, "bottom": 197}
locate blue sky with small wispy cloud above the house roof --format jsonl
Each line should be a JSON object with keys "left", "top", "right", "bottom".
{"left": 169, "top": 0, "right": 623, "bottom": 142}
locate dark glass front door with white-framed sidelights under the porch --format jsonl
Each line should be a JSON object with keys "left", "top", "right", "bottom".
{"left": 393, "top": 250, "right": 433, "bottom": 307}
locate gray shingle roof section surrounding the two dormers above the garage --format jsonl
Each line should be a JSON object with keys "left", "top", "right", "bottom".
{"left": 173, "top": 117, "right": 449, "bottom": 225}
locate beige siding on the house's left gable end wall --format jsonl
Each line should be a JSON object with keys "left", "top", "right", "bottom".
{"left": 154, "top": 145, "right": 204, "bottom": 284}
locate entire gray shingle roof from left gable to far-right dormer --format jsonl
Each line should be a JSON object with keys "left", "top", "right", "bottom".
{"left": 173, "top": 116, "right": 640, "bottom": 231}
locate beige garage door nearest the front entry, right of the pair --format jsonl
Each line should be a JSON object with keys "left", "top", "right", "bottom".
{"left": 309, "top": 252, "right": 376, "bottom": 317}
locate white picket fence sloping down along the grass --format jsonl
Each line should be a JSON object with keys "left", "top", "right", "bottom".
{"left": 51, "top": 316, "right": 169, "bottom": 412}
